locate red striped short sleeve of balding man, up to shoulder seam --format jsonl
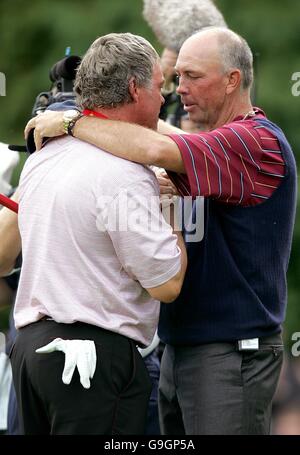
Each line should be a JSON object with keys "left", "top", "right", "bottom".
{"left": 169, "top": 122, "right": 262, "bottom": 204}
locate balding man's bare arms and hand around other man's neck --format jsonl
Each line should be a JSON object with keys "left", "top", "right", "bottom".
{"left": 25, "top": 111, "right": 186, "bottom": 173}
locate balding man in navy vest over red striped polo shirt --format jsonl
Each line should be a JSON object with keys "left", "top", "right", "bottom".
{"left": 27, "top": 28, "right": 297, "bottom": 434}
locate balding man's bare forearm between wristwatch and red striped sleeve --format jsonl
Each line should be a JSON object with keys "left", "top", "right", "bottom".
{"left": 74, "top": 117, "right": 185, "bottom": 172}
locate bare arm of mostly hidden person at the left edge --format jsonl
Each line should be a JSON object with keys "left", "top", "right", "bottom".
{"left": 0, "top": 193, "right": 21, "bottom": 276}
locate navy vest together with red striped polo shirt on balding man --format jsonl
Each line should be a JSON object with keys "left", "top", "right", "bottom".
{"left": 158, "top": 110, "right": 297, "bottom": 346}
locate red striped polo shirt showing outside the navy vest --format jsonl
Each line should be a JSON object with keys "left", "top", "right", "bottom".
{"left": 169, "top": 108, "right": 285, "bottom": 206}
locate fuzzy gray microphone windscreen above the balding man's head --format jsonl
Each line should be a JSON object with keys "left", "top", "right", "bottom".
{"left": 143, "top": 0, "right": 227, "bottom": 53}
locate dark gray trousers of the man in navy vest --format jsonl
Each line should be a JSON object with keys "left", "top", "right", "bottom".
{"left": 159, "top": 335, "right": 283, "bottom": 435}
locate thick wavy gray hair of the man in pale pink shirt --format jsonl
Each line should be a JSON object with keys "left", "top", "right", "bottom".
{"left": 74, "top": 33, "right": 159, "bottom": 109}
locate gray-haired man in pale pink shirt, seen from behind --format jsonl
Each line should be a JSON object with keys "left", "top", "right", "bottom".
{"left": 11, "top": 33, "right": 186, "bottom": 434}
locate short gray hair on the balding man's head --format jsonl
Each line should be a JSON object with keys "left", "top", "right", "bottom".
{"left": 195, "top": 27, "right": 253, "bottom": 89}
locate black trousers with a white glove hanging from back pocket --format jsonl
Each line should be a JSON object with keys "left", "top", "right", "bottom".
{"left": 10, "top": 319, "right": 151, "bottom": 435}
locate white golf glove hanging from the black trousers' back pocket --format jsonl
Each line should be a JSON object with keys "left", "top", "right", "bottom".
{"left": 35, "top": 338, "right": 97, "bottom": 389}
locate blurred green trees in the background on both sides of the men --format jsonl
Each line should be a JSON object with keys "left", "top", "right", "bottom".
{"left": 0, "top": 0, "right": 300, "bottom": 346}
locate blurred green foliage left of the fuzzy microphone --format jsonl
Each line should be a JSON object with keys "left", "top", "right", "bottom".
{"left": 0, "top": 0, "right": 159, "bottom": 142}
